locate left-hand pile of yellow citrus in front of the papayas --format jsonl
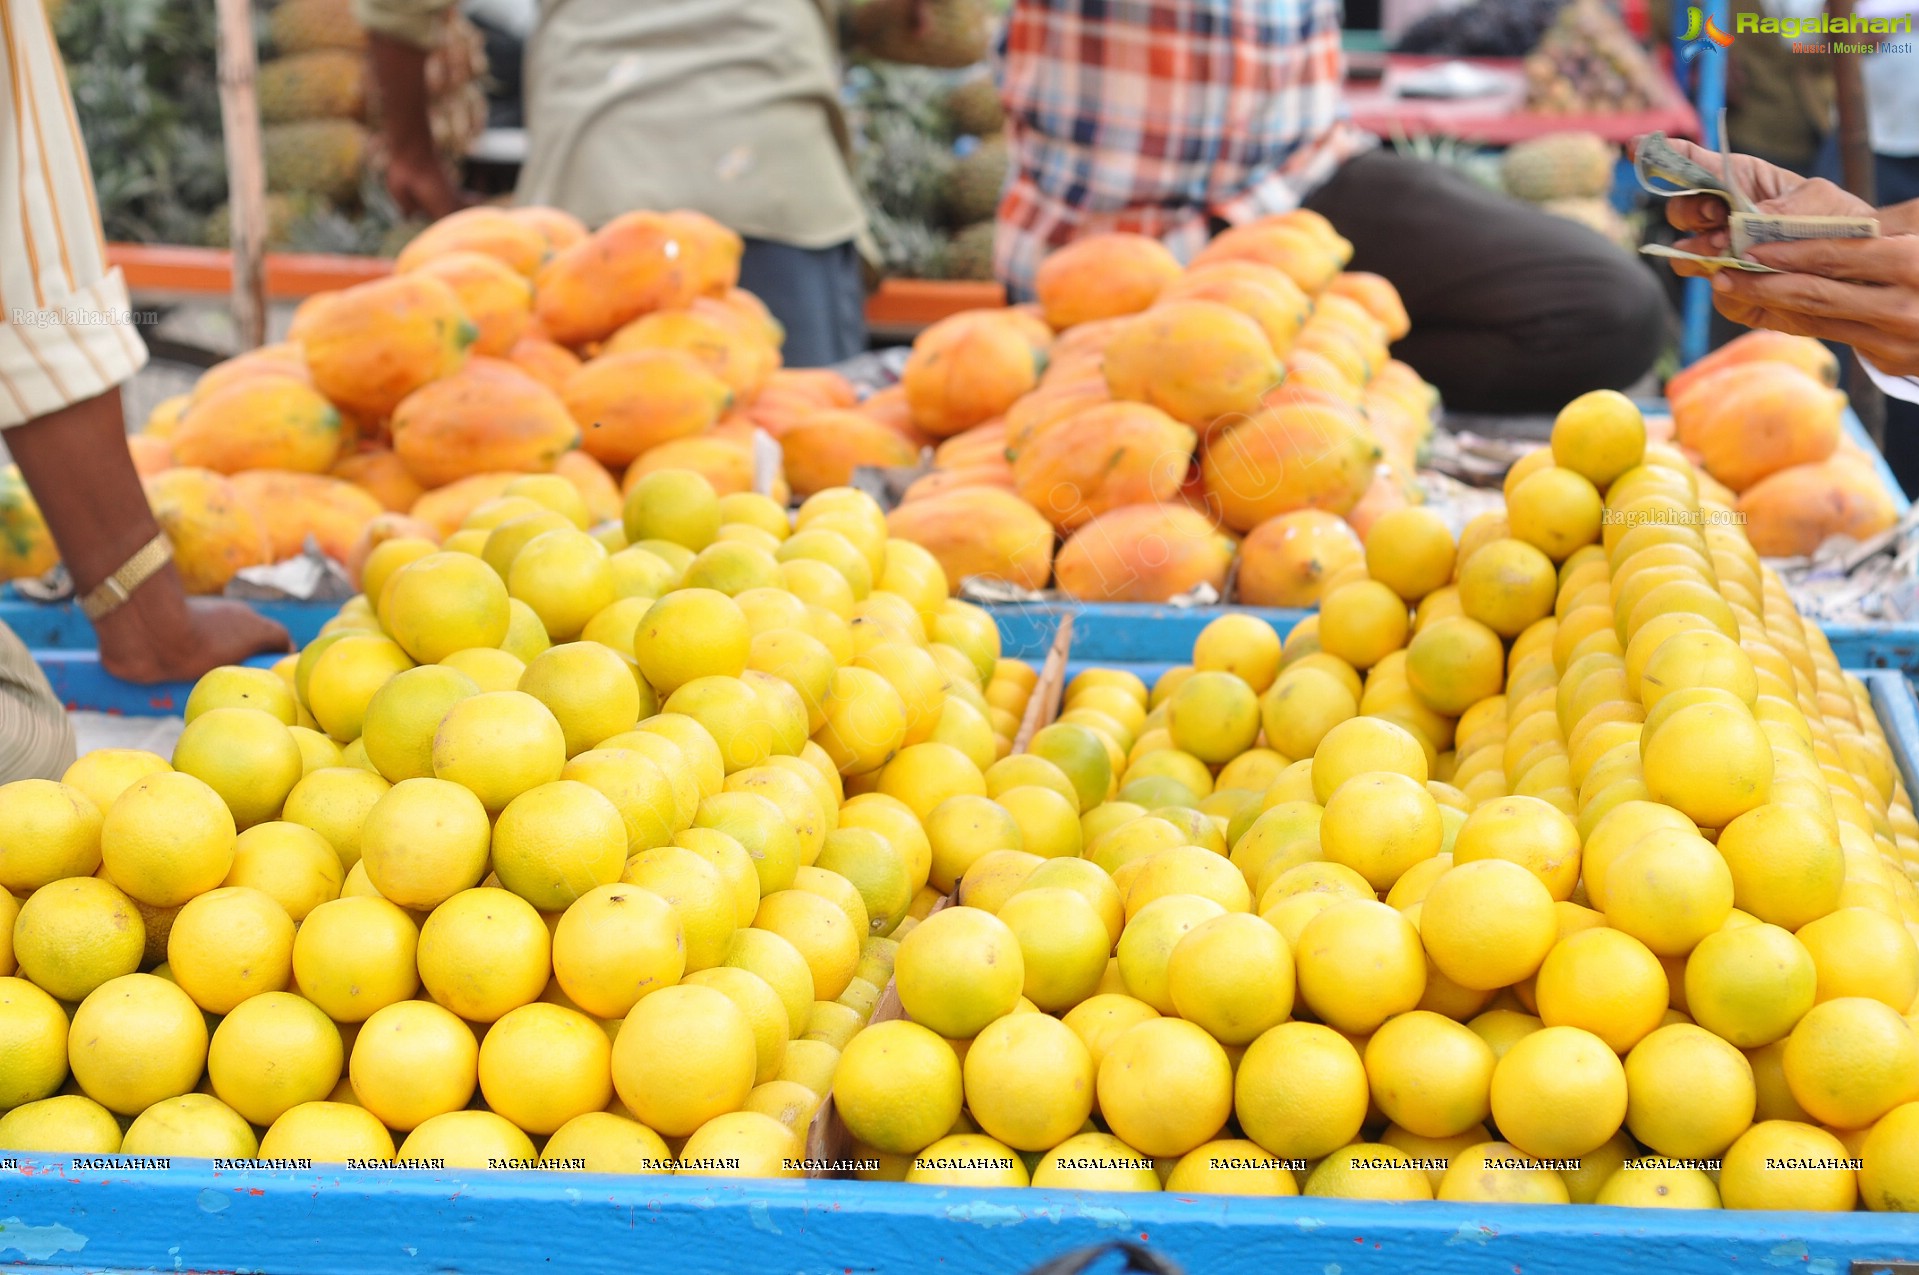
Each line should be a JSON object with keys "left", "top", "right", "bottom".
{"left": 0, "top": 470, "right": 1036, "bottom": 1175}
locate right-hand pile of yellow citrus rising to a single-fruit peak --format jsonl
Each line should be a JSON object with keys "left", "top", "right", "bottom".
{"left": 835, "top": 392, "right": 1919, "bottom": 1210}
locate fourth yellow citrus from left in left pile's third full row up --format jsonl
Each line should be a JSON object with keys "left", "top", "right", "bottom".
{"left": 361, "top": 775, "right": 491, "bottom": 910}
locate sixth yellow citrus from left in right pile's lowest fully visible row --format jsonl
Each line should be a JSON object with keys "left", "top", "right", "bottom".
{"left": 1493, "top": 1027, "right": 1627, "bottom": 1158}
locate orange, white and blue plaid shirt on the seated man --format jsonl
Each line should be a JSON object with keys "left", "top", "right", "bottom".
{"left": 996, "top": 0, "right": 1372, "bottom": 298}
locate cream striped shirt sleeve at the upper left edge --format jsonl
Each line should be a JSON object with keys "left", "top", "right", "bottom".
{"left": 0, "top": 0, "right": 146, "bottom": 428}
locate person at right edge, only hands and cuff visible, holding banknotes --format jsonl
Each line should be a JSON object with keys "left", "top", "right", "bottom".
{"left": 1666, "top": 142, "right": 1919, "bottom": 403}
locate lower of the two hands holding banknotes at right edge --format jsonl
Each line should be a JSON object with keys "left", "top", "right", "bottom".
{"left": 1712, "top": 234, "right": 1919, "bottom": 376}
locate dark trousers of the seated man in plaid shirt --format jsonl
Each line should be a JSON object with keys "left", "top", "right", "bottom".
{"left": 1307, "top": 148, "right": 1671, "bottom": 413}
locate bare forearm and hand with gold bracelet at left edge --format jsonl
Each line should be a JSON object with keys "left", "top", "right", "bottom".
{"left": 6, "top": 388, "right": 288, "bottom": 682}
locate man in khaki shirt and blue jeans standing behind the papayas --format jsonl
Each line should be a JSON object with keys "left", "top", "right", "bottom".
{"left": 355, "top": 0, "right": 984, "bottom": 367}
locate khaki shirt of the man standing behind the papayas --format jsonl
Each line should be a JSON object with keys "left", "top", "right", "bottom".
{"left": 355, "top": 0, "right": 865, "bottom": 248}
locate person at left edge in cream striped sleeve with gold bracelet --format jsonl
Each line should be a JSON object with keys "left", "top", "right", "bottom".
{"left": 0, "top": 0, "right": 286, "bottom": 782}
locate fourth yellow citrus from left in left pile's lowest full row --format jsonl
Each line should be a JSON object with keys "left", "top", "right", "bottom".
{"left": 347, "top": 1000, "right": 480, "bottom": 1131}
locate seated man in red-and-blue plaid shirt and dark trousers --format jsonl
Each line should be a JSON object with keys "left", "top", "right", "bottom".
{"left": 998, "top": 0, "right": 1668, "bottom": 411}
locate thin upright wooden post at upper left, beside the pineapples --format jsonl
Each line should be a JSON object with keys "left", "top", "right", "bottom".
{"left": 217, "top": 0, "right": 267, "bottom": 353}
